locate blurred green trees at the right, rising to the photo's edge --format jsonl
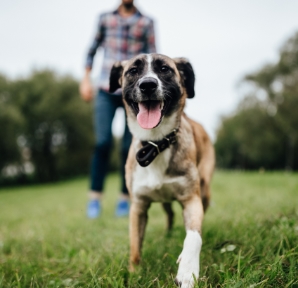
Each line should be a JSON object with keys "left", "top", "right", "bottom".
{"left": 215, "top": 33, "right": 298, "bottom": 170}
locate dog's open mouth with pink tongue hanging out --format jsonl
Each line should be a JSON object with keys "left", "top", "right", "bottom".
{"left": 132, "top": 100, "right": 168, "bottom": 129}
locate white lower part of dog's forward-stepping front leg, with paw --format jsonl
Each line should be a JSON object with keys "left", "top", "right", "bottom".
{"left": 175, "top": 230, "right": 202, "bottom": 288}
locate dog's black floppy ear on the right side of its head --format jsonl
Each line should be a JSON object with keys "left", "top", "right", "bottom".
{"left": 173, "top": 58, "right": 195, "bottom": 98}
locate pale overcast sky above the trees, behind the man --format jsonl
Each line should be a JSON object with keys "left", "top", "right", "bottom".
{"left": 0, "top": 0, "right": 298, "bottom": 139}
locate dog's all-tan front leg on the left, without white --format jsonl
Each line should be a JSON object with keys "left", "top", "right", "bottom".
{"left": 129, "top": 201, "right": 150, "bottom": 271}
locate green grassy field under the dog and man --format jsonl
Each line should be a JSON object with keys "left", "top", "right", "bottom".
{"left": 0, "top": 171, "right": 298, "bottom": 288}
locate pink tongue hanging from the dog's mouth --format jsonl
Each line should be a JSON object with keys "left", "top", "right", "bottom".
{"left": 137, "top": 101, "right": 161, "bottom": 129}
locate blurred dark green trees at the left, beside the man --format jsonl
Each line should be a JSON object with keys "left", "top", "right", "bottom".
{"left": 0, "top": 70, "right": 94, "bottom": 181}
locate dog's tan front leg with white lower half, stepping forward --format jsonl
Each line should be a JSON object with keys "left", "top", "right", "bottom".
{"left": 175, "top": 195, "right": 204, "bottom": 288}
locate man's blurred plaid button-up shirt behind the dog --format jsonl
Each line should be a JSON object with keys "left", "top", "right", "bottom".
{"left": 86, "top": 10, "right": 156, "bottom": 91}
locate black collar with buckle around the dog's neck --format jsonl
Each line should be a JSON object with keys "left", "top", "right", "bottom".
{"left": 136, "top": 129, "right": 178, "bottom": 167}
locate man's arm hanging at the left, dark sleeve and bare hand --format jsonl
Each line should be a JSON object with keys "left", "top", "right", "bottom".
{"left": 80, "top": 17, "right": 105, "bottom": 102}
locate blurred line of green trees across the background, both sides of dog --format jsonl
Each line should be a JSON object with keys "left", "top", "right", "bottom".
{"left": 0, "top": 33, "right": 298, "bottom": 185}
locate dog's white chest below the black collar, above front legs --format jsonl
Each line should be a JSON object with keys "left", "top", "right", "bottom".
{"left": 132, "top": 149, "right": 185, "bottom": 202}
